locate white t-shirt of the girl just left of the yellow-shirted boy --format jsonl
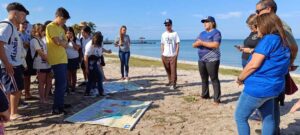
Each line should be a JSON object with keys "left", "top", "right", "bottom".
{"left": 30, "top": 38, "right": 51, "bottom": 69}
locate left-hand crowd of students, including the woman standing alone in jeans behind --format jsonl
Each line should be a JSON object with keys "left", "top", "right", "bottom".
{"left": 0, "top": 2, "right": 130, "bottom": 132}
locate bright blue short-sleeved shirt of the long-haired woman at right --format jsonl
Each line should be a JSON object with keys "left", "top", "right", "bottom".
{"left": 244, "top": 34, "right": 290, "bottom": 98}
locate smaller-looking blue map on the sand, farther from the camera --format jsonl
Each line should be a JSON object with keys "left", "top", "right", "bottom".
{"left": 103, "top": 82, "right": 144, "bottom": 94}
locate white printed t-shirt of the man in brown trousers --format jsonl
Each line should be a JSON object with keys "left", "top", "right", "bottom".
{"left": 161, "top": 31, "right": 180, "bottom": 57}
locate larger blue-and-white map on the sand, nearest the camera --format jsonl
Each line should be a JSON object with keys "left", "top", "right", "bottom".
{"left": 65, "top": 99, "right": 152, "bottom": 130}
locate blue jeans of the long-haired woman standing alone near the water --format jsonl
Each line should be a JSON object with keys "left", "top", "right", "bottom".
{"left": 119, "top": 51, "right": 130, "bottom": 77}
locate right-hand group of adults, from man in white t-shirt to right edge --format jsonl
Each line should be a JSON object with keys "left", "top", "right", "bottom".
{"left": 161, "top": 0, "right": 300, "bottom": 135}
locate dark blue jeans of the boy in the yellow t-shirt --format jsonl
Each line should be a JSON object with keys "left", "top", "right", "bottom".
{"left": 52, "top": 64, "right": 67, "bottom": 109}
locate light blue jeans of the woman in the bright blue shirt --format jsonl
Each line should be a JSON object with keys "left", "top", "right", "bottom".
{"left": 235, "top": 92, "right": 275, "bottom": 135}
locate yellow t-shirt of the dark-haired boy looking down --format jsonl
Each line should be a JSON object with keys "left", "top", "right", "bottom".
{"left": 46, "top": 22, "right": 68, "bottom": 65}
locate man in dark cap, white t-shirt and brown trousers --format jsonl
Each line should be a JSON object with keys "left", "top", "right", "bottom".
{"left": 161, "top": 19, "right": 180, "bottom": 90}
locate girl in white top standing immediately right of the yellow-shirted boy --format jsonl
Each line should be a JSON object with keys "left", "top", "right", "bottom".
{"left": 66, "top": 27, "right": 80, "bottom": 92}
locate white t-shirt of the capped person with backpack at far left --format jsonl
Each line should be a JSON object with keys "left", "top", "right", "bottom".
{"left": 0, "top": 20, "right": 23, "bottom": 68}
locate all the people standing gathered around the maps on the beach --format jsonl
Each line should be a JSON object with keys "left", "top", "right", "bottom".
{"left": 0, "top": 0, "right": 300, "bottom": 135}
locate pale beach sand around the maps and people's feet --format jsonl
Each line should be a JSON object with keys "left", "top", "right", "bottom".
{"left": 5, "top": 58, "right": 300, "bottom": 135}
